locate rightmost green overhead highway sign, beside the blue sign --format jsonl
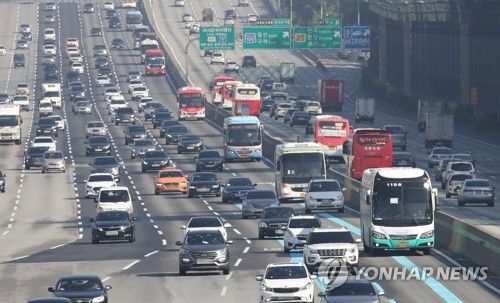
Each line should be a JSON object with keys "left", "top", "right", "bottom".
{"left": 293, "top": 26, "right": 342, "bottom": 49}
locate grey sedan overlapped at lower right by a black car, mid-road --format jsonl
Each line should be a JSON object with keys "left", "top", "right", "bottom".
{"left": 241, "top": 189, "right": 279, "bottom": 219}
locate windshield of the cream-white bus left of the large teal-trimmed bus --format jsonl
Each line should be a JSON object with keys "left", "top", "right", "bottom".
{"left": 281, "top": 153, "right": 326, "bottom": 183}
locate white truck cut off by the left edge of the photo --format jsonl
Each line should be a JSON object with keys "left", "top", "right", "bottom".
{"left": 0, "top": 104, "right": 23, "bottom": 145}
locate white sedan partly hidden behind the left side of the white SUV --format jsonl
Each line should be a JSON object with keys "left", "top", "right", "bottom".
{"left": 283, "top": 215, "right": 321, "bottom": 253}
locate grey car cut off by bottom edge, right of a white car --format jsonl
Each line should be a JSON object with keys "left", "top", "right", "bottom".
{"left": 318, "top": 276, "right": 385, "bottom": 303}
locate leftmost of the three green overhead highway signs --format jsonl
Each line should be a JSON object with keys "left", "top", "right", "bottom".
{"left": 200, "top": 26, "right": 234, "bottom": 50}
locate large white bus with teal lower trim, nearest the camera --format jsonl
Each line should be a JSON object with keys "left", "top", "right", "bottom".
{"left": 359, "top": 167, "right": 438, "bottom": 255}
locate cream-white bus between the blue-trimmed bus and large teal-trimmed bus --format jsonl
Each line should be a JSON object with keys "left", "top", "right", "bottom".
{"left": 274, "top": 142, "right": 328, "bottom": 203}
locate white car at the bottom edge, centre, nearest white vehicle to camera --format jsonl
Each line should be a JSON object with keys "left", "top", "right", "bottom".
{"left": 255, "top": 262, "right": 317, "bottom": 303}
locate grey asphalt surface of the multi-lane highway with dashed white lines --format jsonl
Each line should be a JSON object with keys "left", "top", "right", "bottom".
{"left": 0, "top": 0, "right": 498, "bottom": 302}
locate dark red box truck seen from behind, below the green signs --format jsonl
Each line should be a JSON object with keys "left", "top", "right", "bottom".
{"left": 318, "top": 79, "right": 344, "bottom": 111}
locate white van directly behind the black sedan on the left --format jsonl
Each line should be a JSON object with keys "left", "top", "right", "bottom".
{"left": 95, "top": 186, "right": 134, "bottom": 215}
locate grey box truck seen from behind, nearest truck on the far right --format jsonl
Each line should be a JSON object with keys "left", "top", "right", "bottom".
{"left": 425, "top": 113, "right": 454, "bottom": 148}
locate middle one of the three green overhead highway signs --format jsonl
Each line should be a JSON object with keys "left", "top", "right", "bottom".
{"left": 242, "top": 27, "right": 291, "bottom": 49}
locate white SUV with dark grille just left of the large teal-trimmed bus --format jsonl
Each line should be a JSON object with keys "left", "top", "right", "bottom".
{"left": 304, "top": 227, "right": 361, "bottom": 273}
